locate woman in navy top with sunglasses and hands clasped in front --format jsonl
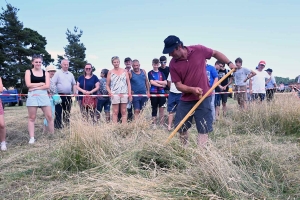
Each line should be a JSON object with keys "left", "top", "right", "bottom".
{"left": 77, "top": 63, "right": 100, "bottom": 120}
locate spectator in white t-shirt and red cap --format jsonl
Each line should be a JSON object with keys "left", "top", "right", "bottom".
{"left": 250, "top": 61, "right": 270, "bottom": 101}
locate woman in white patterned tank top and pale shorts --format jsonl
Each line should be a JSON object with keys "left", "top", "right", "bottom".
{"left": 106, "top": 56, "right": 132, "bottom": 123}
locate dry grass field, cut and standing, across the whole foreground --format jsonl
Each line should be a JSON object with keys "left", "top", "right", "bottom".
{"left": 0, "top": 94, "right": 300, "bottom": 199}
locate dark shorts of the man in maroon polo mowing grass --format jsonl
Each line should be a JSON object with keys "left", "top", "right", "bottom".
{"left": 175, "top": 97, "right": 213, "bottom": 134}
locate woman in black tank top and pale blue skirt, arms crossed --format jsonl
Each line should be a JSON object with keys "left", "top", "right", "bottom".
{"left": 25, "top": 55, "right": 54, "bottom": 144}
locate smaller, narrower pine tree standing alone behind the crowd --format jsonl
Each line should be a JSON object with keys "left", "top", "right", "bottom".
{"left": 57, "top": 26, "right": 90, "bottom": 80}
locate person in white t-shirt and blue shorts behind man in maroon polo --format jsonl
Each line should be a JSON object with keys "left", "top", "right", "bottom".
{"left": 167, "top": 73, "right": 181, "bottom": 131}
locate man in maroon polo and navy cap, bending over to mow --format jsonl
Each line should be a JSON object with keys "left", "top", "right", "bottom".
{"left": 163, "top": 35, "right": 236, "bottom": 147}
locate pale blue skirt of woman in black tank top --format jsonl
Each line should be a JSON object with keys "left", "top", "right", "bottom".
{"left": 26, "top": 90, "right": 51, "bottom": 107}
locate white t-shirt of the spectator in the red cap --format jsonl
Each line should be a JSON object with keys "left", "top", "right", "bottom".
{"left": 251, "top": 70, "right": 270, "bottom": 94}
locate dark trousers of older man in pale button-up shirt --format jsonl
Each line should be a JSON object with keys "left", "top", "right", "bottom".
{"left": 54, "top": 96, "right": 72, "bottom": 129}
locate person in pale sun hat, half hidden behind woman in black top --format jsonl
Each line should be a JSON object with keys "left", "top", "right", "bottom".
{"left": 43, "top": 65, "right": 57, "bottom": 132}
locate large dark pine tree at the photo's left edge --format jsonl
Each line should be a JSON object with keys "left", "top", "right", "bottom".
{"left": 0, "top": 4, "right": 54, "bottom": 92}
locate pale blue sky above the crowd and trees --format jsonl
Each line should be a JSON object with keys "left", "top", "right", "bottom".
{"left": 0, "top": 0, "right": 300, "bottom": 78}
